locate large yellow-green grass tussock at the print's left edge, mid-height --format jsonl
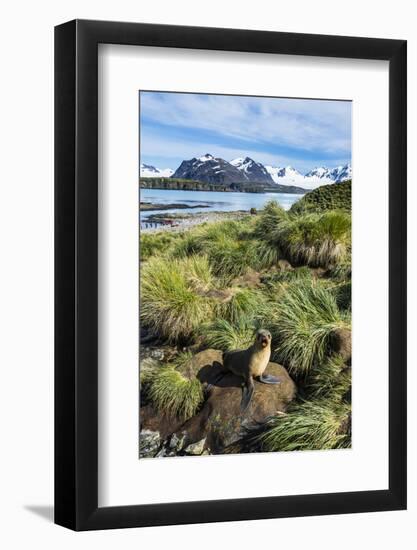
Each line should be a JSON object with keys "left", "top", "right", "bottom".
{"left": 140, "top": 256, "right": 213, "bottom": 342}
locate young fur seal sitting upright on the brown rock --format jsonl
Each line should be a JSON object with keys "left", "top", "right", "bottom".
{"left": 210, "top": 329, "right": 281, "bottom": 412}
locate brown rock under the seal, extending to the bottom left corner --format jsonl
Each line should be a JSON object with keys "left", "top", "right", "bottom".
{"left": 141, "top": 349, "right": 296, "bottom": 456}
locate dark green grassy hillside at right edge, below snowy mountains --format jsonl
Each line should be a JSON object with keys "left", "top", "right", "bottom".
{"left": 291, "top": 180, "right": 352, "bottom": 213}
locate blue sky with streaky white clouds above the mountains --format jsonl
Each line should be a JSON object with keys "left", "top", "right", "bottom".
{"left": 140, "top": 92, "right": 351, "bottom": 173}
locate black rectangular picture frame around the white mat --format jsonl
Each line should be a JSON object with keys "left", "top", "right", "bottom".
{"left": 55, "top": 20, "right": 407, "bottom": 531}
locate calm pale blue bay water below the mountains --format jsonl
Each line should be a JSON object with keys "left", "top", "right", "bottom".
{"left": 140, "top": 189, "right": 302, "bottom": 222}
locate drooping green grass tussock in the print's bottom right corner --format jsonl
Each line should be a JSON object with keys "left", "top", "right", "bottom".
{"left": 259, "top": 399, "right": 351, "bottom": 451}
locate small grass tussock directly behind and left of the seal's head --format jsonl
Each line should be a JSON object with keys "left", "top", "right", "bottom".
{"left": 202, "top": 317, "right": 257, "bottom": 351}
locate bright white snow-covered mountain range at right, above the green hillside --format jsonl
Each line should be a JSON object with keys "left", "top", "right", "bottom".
{"left": 265, "top": 164, "right": 352, "bottom": 189}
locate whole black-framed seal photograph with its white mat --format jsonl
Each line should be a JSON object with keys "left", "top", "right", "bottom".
{"left": 55, "top": 20, "right": 406, "bottom": 530}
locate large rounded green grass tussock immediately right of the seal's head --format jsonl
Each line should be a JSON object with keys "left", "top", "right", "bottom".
{"left": 272, "top": 281, "right": 349, "bottom": 374}
